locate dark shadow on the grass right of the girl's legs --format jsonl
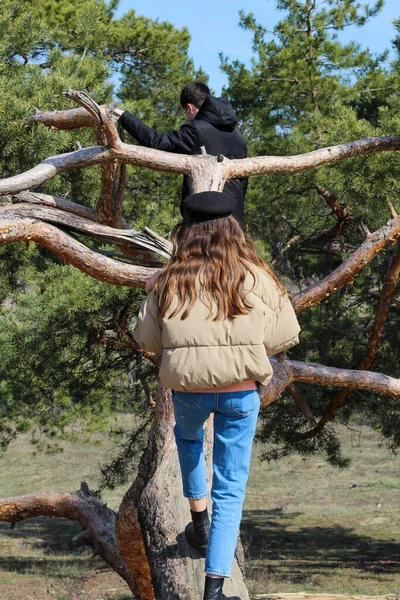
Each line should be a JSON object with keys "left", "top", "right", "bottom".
{"left": 241, "top": 509, "right": 400, "bottom": 581}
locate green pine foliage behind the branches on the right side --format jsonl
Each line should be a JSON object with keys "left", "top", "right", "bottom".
{"left": 222, "top": 0, "right": 400, "bottom": 466}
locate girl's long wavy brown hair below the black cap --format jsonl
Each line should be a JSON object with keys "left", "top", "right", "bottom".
{"left": 154, "top": 216, "right": 286, "bottom": 321}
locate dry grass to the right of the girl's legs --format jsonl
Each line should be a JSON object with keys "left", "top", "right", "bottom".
{"left": 243, "top": 426, "right": 400, "bottom": 596}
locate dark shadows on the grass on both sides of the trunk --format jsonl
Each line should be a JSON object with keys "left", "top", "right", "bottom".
{"left": 0, "top": 509, "right": 400, "bottom": 581}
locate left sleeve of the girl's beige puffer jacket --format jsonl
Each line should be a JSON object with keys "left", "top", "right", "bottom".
{"left": 133, "top": 292, "right": 163, "bottom": 355}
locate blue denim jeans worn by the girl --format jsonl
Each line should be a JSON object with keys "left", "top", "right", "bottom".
{"left": 172, "top": 390, "right": 260, "bottom": 577}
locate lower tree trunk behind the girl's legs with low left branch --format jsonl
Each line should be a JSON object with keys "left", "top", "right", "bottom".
{"left": 0, "top": 386, "right": 249, "bottom": 600}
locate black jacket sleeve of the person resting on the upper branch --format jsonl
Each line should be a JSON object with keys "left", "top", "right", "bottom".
{"left": 119, "top": 110, "right": 197, "bottom": 154}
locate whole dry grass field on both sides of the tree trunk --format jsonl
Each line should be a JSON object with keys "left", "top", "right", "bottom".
{"left": 0, "top": 426, "right": 400, "bottom": 600}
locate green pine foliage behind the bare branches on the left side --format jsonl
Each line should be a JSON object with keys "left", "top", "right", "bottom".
{"left": 0, "top": 0, "right": 204, "bottom": 454}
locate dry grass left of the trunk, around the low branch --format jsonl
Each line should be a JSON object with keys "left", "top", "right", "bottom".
{"left": 0, "top": 417, "right": 132, "bottom": 600}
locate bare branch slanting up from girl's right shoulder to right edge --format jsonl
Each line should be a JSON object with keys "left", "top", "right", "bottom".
{"left": 292, "top": 217, "right": 400, "bottom": 313}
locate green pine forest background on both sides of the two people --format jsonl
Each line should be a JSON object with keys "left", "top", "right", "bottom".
{"left": 0, "top": 0, "right": 400, "bottom": 596}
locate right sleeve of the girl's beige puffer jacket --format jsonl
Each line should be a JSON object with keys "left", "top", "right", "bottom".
{"left": 264, "top": 296, "right": 300, "bottom": 356}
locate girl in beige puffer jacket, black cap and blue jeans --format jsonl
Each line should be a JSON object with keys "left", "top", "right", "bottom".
{"left": 134, "top": 192, "right": 300, "bottom": 600}
